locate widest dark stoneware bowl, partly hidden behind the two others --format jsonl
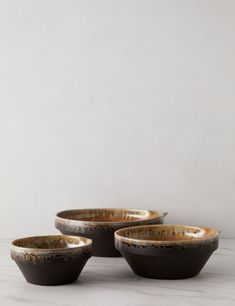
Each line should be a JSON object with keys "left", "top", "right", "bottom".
{"left": 55, "top": 208, "right": 166, "bottom": 257}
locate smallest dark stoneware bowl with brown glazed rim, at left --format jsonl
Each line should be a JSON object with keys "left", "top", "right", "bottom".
{"left": 11, "top": 235, "right": 92, "bottom": 286}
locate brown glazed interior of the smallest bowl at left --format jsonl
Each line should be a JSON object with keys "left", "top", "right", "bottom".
{"left": 12, "top": 235, "right": 91, "bottom": 250}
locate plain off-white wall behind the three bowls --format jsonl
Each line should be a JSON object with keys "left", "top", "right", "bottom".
{"left": 0, "top": 0, "right": 235, "bottom": 238}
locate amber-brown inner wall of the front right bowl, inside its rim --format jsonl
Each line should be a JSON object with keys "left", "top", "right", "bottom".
{"left": 120, "top": 226, "right": 216, "bottom": 241}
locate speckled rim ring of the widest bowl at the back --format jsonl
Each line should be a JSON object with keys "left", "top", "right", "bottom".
{"left": 56, "top": 208, "right": 168, "bottom": 226}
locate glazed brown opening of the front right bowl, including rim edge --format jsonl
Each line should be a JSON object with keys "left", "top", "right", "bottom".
{"left": 115, "top": 225, "right": 218, "bottom": 243}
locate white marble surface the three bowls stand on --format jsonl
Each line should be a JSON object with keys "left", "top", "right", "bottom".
{"left": 0, "top": 239, "right": 235, "bottom": 306}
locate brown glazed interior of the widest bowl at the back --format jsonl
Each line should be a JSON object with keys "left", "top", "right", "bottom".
{"left": 57, "top": 208, "right": 162, "bottom": 223}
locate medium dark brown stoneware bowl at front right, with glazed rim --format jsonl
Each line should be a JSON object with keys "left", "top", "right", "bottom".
{"left": 115, "top": 225, "right": 219, "bottom": 279}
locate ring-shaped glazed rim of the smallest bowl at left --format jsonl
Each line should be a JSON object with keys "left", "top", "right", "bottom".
{"left": 10, "top": 235, "right": 92, "bottom": 253}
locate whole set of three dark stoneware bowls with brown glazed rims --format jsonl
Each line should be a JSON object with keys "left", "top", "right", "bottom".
{"left": 11, "top": 208, "right": 219, "bottom": 285}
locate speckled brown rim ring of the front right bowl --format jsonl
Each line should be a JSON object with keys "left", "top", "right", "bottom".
{"left": 114, "top": 224, "right": 220, "bottom": 246}
